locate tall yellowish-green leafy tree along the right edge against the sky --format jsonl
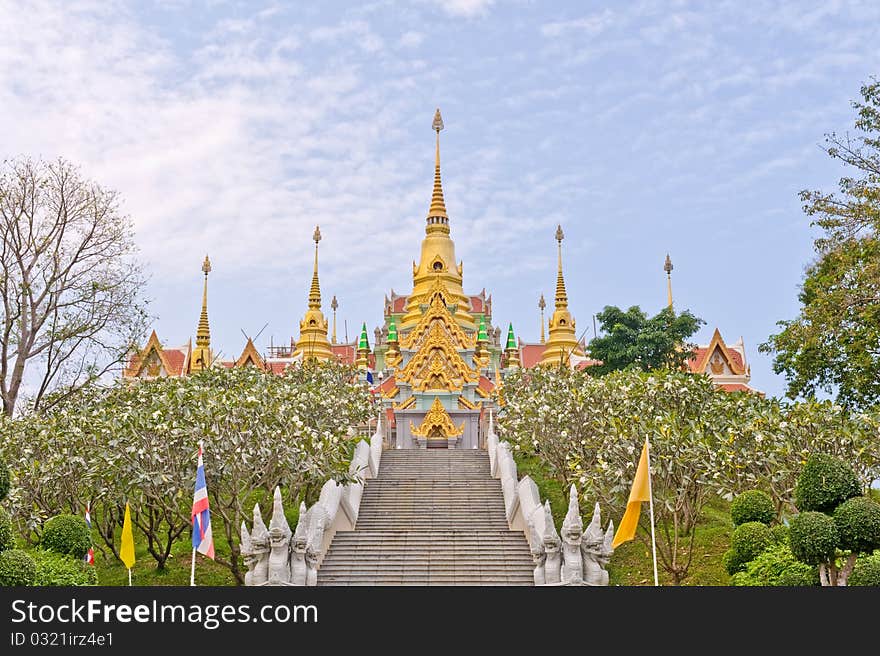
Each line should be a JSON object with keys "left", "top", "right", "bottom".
{"left": 759, "top": 79, "right": 880, "bottom": 408}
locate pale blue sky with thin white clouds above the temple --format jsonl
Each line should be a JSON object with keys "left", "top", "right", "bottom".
{"left": 0, "top": 0, "right": 880, "bottom": 395}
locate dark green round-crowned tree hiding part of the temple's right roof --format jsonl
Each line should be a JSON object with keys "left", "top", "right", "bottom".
{"left": 587, "top": 305, "right": 706, "bottom": 376}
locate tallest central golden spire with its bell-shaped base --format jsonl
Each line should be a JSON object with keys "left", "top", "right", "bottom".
{"left": 398, "top": 108, "right": 476, "bottom": 333}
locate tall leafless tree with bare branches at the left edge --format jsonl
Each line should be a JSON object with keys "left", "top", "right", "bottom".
{"left": 0, "top": 159, "right": 147, "bottom": 416}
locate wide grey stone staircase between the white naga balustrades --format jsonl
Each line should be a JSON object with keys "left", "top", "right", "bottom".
{"left": 318, "top": 449, "right": 534, "bottom": 585}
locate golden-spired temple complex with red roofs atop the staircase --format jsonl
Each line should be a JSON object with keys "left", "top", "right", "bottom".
{"left": 123, "top": 109, "right": 754, "bottom": 449}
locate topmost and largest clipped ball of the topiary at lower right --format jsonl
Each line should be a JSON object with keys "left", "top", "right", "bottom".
{"left": 794, "top": 453, "right": 862, "bottom": 515}
